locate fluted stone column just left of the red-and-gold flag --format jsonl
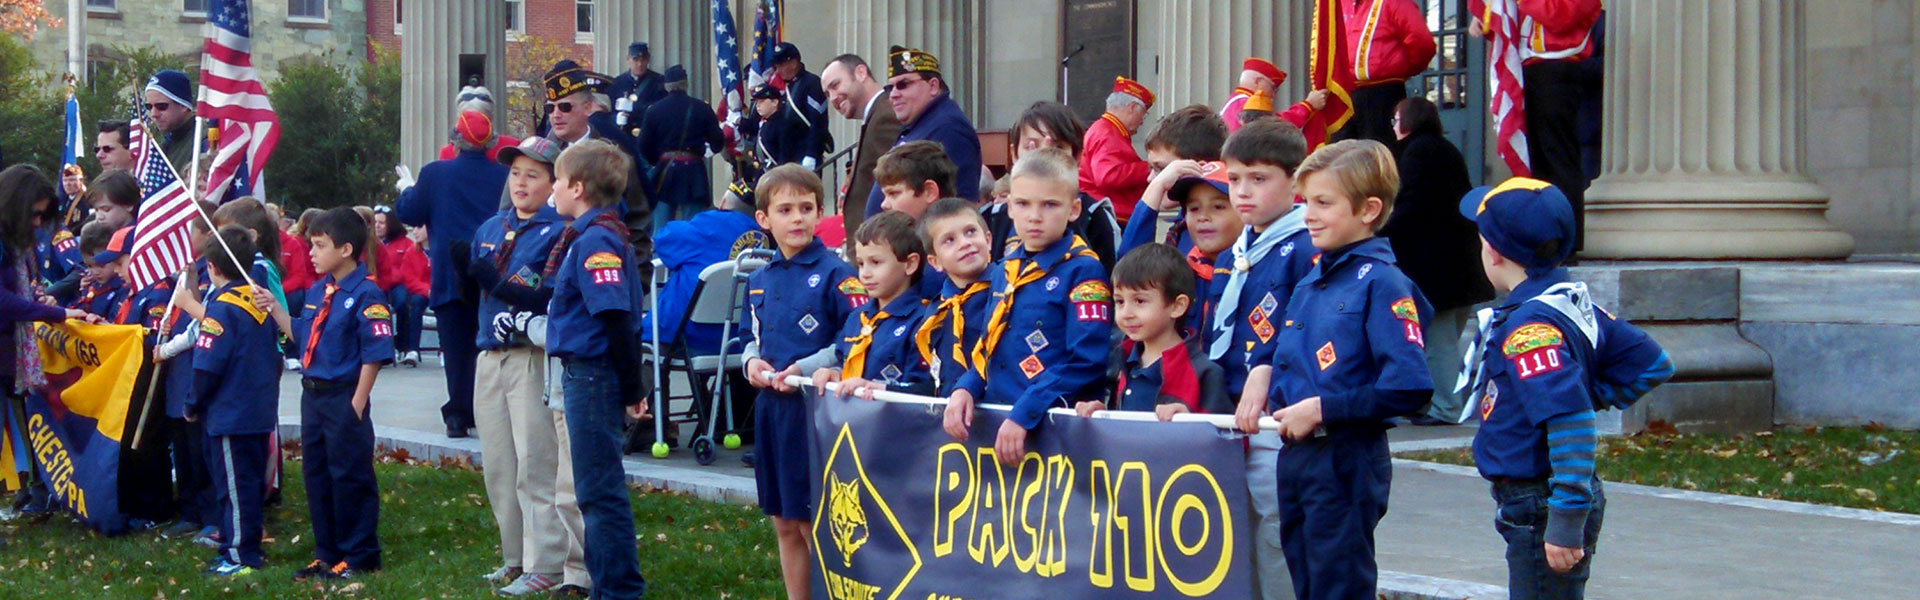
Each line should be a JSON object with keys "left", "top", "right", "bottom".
{"left": 1146, "top": 0, "right": 1313, "bottom": 123}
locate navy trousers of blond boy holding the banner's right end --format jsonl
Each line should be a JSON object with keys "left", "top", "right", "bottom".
{"left": 1277, "top": 431, "right": 1394, "bottom": 600}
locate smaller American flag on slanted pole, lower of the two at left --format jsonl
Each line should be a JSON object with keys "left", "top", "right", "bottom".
{"left": 127, "top": 123, "right": 200, "bottom": 290}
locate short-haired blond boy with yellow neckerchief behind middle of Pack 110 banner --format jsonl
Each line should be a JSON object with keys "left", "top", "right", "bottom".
{"left": 945, "top": 148, "right": 1114, "bottom": 465}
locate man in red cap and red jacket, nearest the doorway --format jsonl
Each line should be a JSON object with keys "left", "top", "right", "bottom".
{"left": 1079, "top": 77, "right": 1154, "bottom": 223}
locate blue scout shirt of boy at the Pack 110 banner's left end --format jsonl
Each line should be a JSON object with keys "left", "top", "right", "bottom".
{"left": 747, "top": 238, "right": 868, "bottom": 371}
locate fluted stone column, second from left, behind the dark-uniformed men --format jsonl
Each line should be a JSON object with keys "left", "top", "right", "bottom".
{"left": 593, "top": 0, "right": 714, "bottom": 100}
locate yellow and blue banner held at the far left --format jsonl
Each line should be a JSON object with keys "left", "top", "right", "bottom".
{"left": 23, "top": 321, "right": 146, "bottom": 535}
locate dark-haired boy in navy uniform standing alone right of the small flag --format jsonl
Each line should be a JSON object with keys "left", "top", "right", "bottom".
{"left": 253, "top": 208, "right": 394, "bottom": 581}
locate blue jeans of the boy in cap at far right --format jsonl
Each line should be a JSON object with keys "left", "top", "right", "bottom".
{"left": 1494, "top": 477, "right": 1607, "bottom": 600}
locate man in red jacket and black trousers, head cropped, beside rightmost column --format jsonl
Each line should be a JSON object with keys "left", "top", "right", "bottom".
{"left": 1467, "top": 0, "right": 1599, "bottom": 248}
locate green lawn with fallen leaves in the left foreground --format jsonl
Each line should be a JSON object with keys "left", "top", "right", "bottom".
{"left": 0, "top": 460, "right": 783, "bottom": 600}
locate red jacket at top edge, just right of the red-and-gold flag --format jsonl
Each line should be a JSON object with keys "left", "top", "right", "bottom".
{"left": 1340, "top": 0, "right": 1438, "bottom": 87}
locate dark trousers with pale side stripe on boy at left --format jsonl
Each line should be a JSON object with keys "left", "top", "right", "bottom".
{"left": 207, "top": 433, "right": 267, "bottom": 567}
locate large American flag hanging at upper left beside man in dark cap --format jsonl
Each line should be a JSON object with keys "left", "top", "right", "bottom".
{"left": 198, "top": 0, "right": 280, "bottom": 204}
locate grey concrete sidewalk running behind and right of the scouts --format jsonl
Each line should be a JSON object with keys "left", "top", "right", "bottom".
{"left": 280, "top": 358, "right": 1920, "bottom": 598}
